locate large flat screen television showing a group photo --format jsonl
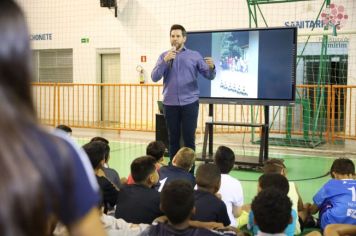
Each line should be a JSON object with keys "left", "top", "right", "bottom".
{"left": 185, "top": 27, "right": 297, "bottom": 106}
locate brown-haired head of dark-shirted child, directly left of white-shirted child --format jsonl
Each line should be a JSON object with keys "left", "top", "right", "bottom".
{"left": 196, "top": 163, "right": 221, "bottom": 193}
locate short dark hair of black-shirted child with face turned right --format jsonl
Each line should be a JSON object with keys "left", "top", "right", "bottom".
{"left": 131, "top": 156, "right": 156, "bottom": 183}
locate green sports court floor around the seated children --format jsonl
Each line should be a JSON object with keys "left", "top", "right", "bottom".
{"left": 75, "top": 135, "right": 336, "bottom": 203}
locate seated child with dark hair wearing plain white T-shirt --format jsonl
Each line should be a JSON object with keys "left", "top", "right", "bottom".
{"left": 214, "top": 146, "right": 244, "bottom": 227}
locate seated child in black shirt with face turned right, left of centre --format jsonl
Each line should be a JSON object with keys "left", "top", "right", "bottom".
{"left": 115, "top": 156, "right": 162, "bottom": 224}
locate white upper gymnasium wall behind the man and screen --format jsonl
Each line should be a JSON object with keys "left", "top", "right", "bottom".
{"left": 18, "top": 0, "right": 356, "bottom": 84}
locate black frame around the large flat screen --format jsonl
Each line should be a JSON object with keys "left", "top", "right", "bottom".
{"left": 187, "top": 27, "right": 298, "bottom": 106}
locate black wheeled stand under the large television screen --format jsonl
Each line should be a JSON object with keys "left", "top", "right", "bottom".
{"left": 198, "top": 104, "right": 269, "bottom": 170}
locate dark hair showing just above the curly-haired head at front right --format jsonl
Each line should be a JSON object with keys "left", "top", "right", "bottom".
{"left": 258, "top": 173, "right": 289, "bottom": 195}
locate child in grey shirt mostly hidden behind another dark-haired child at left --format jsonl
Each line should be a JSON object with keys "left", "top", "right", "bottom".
{"left": 90, "top": 136, "right": 121, "bottom": 188}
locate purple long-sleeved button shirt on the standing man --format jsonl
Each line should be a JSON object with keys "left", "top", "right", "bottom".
{"left": 151, "top": 47, "right": 216, "bottom": 106}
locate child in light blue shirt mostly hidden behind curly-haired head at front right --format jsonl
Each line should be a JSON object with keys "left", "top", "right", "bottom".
{"left": 247, "top": 173, "right": 298, "bottom": 236}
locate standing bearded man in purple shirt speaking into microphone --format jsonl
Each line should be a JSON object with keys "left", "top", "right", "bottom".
{"left": 151, "top": 25, "right": 216, "bottom": 171}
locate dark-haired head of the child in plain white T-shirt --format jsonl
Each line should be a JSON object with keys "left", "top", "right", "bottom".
{"left": 214, "top": 146, "right": 235, "bottom": 174}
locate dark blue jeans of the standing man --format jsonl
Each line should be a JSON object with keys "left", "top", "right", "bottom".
{"left": 164, "top": 101, "right": 199, "bottom": 165}
